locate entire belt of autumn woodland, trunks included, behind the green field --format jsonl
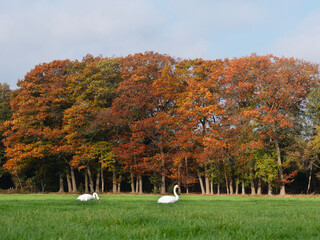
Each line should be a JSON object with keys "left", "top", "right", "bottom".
{"left": 0, "top": 52, "right": 320, "bottom": 196}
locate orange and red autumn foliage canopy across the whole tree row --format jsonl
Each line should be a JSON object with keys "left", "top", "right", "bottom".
{"left": 4, "top": 52, "right": 319, "bottom": 191}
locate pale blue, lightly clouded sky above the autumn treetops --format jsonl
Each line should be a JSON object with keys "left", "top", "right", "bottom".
{"left": 0, "top": 0, "right": 320, "bottom": 89}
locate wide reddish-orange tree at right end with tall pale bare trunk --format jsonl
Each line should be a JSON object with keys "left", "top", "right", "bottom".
{"left": 227, "top": 55, "right": 318, "bottom": 195}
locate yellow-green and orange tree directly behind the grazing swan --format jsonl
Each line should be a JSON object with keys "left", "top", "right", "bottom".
{"left": 64, "top": 55, "right": 121, "bottom": 192}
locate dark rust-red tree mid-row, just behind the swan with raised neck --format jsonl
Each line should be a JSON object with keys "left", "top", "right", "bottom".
{"left": 112, "top": 52, "right": 174, "bottom": 193}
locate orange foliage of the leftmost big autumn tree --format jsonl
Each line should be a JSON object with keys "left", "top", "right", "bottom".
{"left": 4, "top": 60, "right": 71, "bottom": 191}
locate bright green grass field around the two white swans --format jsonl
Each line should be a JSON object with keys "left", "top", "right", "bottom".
{"left": 0, "top": 194, "right": 320, "bottom": 240}
